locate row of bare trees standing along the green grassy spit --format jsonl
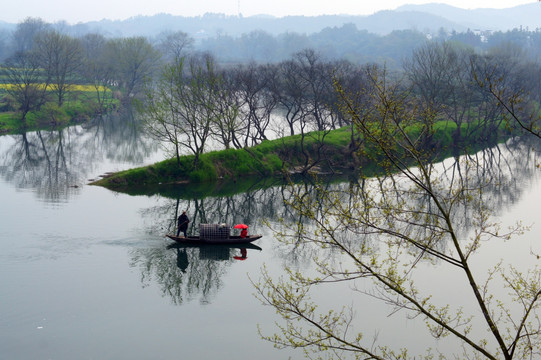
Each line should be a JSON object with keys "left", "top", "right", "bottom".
{"left": 140, "top": 42, "right": 541, "bottom": 171}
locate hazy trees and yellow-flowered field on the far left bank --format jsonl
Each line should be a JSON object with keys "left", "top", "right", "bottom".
{"left": 0, "top": 18, "right": 167, "bottom": 131}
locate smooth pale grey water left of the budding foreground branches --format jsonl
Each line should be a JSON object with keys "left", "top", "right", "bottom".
{"left": 0, "top": 116, "right": 292, "bottom": 359}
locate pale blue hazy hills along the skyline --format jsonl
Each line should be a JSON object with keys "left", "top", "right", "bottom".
{"left": 0, "top": 2, "right": 541, "bottom": 40}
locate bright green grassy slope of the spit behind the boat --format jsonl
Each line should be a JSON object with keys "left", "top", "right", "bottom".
{"left": 91, "top": 122, "right": 509, "bottom": 191}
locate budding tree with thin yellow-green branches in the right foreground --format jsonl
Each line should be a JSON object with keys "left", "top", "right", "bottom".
{"left": 256, "top": 66, "right": 541, "bottom": 359}
